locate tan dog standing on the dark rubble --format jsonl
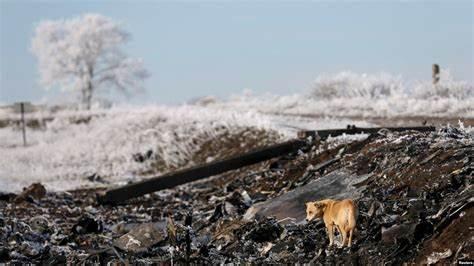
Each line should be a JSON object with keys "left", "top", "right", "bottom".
{"left": 306, "top": 199, "right": 357, "bottom": 247}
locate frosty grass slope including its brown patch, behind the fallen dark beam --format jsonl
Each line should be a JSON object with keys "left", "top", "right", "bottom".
{"left": 0, "top": 106, "right": 369, "bottom": 191}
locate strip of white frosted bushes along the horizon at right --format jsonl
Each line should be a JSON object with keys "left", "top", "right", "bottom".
{"left": 213, "top": 71, "right": 474, "bottom": 118}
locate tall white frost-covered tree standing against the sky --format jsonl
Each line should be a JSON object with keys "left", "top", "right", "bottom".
{"left": 31, "top": 14, "right": 149, "bottom": 109}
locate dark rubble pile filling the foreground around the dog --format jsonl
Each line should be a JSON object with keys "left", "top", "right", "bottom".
{"left": 0, "top": 127, "right": 474, "bottom": 265}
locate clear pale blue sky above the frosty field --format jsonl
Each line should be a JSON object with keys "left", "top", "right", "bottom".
{"left": 0, "top": 0, "right": 474, "bottom": 103}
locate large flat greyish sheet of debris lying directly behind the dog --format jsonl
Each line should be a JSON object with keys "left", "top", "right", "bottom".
{"left": 244, "top": 169, "right": 370, "bottom": 222}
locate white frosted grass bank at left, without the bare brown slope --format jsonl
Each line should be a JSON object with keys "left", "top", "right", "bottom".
{"left": 0, "top": 106, "right": 284, "bottom": 191}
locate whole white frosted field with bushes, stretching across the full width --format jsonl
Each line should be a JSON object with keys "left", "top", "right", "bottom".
{"left": 0, "top": 72, "right": 474, "bottom": 191}
